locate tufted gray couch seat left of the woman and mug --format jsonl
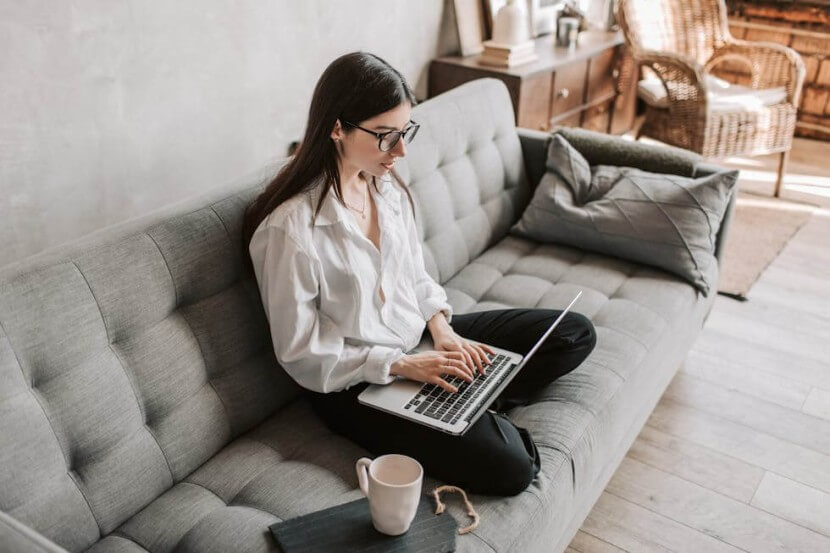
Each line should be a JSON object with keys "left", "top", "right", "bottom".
{"left": 82, "top": 397, "right": 436, "bottom": 553}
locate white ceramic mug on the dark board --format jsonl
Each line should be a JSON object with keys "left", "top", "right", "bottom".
{"left": 355, "top": 453, "right": 424, "bottom": 536}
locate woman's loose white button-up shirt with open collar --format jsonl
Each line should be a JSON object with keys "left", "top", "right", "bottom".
{"left": 249, "top": 175, "right": 453, "bottom": 393}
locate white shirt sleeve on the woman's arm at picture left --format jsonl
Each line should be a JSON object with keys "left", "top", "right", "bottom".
{"left": 250, "top": 226, "right": 404, "bottom": 393}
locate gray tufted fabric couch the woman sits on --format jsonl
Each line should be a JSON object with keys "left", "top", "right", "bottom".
{"left": 0, "top": 79, "right": 734, "bottom": 553}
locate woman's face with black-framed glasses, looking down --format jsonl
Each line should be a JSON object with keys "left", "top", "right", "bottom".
{"left": 331, "top": 102, "right": 412, "bottom": 177}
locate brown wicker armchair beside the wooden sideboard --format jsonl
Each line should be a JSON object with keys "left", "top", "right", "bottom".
{"left": 617, "top": 0, "right": 806, "bottom": 196}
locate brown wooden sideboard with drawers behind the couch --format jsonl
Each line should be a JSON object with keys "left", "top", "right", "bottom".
{"left": 428, "top": 31, "right": 637, "bottom": 134}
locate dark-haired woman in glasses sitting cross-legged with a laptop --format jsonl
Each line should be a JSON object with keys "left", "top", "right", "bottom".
{"left": 243, "top": 52, "right": 596, "bottom": 495}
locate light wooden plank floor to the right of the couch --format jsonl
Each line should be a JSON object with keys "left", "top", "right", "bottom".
{"left": 567, "top": 135, "right": 830, "bottom": 553}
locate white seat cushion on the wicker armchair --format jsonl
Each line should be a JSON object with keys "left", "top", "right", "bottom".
{"left": 637, "top": 75, "right": 787, "bottom": 111}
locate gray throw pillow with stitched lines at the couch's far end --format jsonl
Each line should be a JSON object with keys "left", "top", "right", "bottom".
{"left": 511, "top": 134, "right": 738, "bottom": 296}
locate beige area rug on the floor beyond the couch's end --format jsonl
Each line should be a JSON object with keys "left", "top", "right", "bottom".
{"left": 718, "top": 190, "right": 818, "bottom": 301}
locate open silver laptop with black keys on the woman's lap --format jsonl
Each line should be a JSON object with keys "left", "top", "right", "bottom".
{"left": 357, "top": 290, "right": 582, "bottom": 435}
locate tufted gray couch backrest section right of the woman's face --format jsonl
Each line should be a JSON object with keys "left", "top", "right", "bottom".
{"left": 398, "top": 78, "right": 532, "bottom": 284}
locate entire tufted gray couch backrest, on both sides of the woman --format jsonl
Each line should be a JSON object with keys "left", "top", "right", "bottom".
{"left": 0, "top": 75, "right": 529, "bottom": 551}
